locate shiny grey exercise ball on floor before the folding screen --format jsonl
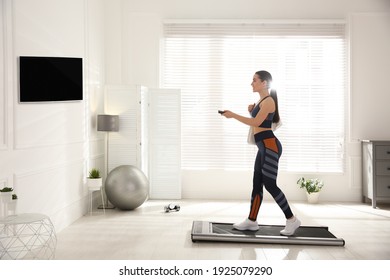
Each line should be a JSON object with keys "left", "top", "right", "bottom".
{"left": 104, "top": 165, "right": 149, "bottom": 210}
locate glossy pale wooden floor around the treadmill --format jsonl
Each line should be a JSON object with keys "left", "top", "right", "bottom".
{"left": 56, "top": 200, "right": 390, "bottom": 260}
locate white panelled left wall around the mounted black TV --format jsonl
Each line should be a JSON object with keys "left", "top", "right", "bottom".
{"left": 0, "top": 0, "right": 104, "bottom": 231}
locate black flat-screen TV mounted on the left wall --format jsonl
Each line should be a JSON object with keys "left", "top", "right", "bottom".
{"left": 19, "top": 56, "right": 83, "bottom": 102}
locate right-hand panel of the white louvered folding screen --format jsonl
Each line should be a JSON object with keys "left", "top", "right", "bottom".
{"left": 149, "top": 89, "right": 181, "bottom": 199}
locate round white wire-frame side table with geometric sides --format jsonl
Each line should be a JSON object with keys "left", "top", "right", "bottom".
{"left": 0, "top": 213, "right": 57, "bottom": 260}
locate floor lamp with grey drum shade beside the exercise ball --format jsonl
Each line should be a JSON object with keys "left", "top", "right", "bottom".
{"left": 97, "top": 115, "right": 119, "bottom": 209}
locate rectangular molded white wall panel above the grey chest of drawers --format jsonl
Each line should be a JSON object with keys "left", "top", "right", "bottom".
{"left": 349, "top": 12, "right": 390, "bottom": 140}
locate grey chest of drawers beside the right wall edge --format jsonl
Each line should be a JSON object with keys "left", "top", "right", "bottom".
{"left": 362, "top": 140, "right": 390, "bottom": 208}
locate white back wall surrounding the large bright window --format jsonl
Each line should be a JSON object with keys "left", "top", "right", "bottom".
{"left": 106, "top": 0, "right": 390, "bottom": 201}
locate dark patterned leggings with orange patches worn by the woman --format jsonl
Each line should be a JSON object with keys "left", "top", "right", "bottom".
{"left": 248, "top": 130, "right": 293, "bottom": 221}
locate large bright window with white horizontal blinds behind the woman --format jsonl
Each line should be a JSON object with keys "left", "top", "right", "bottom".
{"left": 161, "top": 21, "right": 346, "bottom": 172}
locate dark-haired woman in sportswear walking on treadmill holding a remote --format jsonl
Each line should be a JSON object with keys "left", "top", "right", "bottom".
{"left": 222, "top": 71, "right": 301, "bottom": 236}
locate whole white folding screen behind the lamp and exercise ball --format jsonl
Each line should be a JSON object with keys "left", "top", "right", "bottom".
{"left": 105, "top": 85, "right": 181, "bottom": 199}
